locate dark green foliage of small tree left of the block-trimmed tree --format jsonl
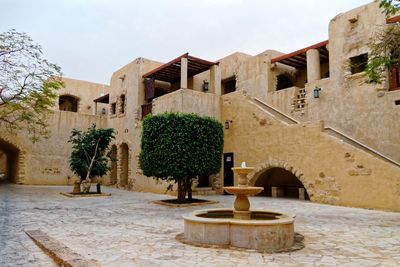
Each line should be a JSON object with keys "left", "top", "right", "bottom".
{"left": 68, "top": 124, "right": 115, "bottom": 181}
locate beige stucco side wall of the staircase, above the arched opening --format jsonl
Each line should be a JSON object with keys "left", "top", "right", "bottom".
{"left": 221, "top": 92, "right": 400, "bottom": 211}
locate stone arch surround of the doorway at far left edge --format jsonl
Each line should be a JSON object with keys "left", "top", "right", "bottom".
{"left": 0, "top": 136, "right": 26, "bottom": 184}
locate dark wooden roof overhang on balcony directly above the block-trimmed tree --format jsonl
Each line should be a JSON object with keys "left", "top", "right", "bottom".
{"left": 143, "top": 53, "right": 218, "bottom": 83}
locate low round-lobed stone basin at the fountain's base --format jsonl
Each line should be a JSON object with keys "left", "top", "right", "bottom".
{"left": 183, "top": 209, "right": 294, "bottom": 252}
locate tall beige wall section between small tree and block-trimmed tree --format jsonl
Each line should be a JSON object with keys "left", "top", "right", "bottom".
{"left": 105, "top": 58, "right": 177, "bottom": 193}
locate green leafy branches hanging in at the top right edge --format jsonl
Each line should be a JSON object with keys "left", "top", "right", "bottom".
{"left": 365, "top": 0, "right": 400, "bottom": 84}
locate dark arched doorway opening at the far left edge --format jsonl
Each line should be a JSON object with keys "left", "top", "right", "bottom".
{"left": 0, "top": 139, "right": 20, "bottom": 183}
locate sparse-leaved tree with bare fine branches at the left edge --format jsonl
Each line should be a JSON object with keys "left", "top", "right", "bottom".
{"left": 0, "top": 30, "right": 63, "bottom": 141}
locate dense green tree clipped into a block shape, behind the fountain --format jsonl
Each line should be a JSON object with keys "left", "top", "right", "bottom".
{"left": 140, "top": 113, "right": 223, "bottom": 202}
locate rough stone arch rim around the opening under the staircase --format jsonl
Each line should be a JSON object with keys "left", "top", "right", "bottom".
{"left": 248, "top": 159, "right": 313, "bottom": 201}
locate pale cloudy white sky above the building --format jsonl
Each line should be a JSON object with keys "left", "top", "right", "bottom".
{"left": 0, "top": 0, "right": 371, "bottom": 84}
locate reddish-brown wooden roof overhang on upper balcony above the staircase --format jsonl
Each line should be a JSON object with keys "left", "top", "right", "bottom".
{"left": 271, "top": 40, "right": 329, "bottom": 68}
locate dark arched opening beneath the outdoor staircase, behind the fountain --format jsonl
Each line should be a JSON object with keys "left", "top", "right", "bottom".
{"left": 254, "top": 168, "right": 310, "bottom": 200}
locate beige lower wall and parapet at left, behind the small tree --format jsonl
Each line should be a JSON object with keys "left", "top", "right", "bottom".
{"left": 0, "top": 111, "right": 106, "bottom": 184}
